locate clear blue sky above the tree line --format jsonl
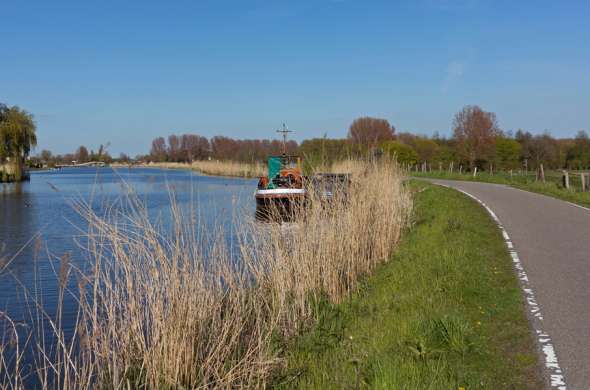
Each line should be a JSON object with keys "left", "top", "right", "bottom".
{"left": 0, "top": 0, "right": 590, "bottom": 155}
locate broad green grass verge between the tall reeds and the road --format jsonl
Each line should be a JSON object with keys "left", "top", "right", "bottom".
{"left": 274, "top": 182, "right": 543, "bottom": 390}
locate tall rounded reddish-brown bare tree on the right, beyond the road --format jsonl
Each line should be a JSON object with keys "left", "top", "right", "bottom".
{"left": 453, "top": 106, "right": 500, "bottom": 169}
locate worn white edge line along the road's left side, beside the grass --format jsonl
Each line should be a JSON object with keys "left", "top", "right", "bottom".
{"left": 434, "top": 182, "right": 568, "bottom": 390}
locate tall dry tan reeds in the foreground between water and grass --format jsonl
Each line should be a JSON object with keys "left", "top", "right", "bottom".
{"left": 0, "top": 162, "right": 412, "bottom": 389}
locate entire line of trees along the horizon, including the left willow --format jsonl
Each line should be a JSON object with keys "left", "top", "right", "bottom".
{"left": 16, "top": 105, "right": 590, "bottom": 174}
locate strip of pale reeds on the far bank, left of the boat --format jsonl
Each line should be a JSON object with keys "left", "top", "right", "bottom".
{"left": 111, "top": 160, "right": 266, "bottom": 178}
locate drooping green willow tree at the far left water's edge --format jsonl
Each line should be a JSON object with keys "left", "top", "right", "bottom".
{"left": 0, "top": 105, "right": 37, "bottom": 181}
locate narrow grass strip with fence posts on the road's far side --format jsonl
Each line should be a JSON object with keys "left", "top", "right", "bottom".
{"left": 410, "top": 171, "right": 590, "bottom": 207}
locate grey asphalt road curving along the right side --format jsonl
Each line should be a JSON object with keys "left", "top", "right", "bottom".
{"left": 431, "top": 180, "right": 590, "bottom": 389}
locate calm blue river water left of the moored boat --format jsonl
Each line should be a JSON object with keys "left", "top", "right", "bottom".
{"left": 0, "top": 168, "right": 256, "bottom": 354}
